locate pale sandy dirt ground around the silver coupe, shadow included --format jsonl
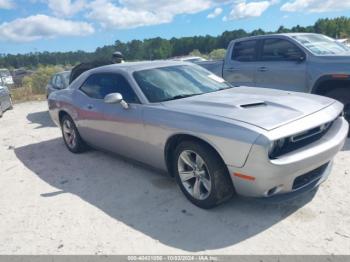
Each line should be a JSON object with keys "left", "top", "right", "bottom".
{"left": 0, "top": 102, "right": 350, "bottom": 254}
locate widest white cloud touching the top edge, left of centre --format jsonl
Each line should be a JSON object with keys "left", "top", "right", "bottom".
{"left": 87, "top": 0, "right": 215, "bottom": 28}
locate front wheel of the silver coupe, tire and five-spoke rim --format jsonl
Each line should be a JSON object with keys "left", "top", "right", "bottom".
{"left": 172, "top": 141, "right": 234, "bottom": 209}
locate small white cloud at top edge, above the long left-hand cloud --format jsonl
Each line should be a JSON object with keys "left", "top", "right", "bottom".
{"left": 47, "top": 0, "right": 86, "bottom": 16}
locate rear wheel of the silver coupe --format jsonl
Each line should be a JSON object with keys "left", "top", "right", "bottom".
{"left": 61, "top": 115, "right": 87, "bottom": 154}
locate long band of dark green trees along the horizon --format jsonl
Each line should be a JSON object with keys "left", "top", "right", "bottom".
{"left": 0, "top": 17, "right": 350, "bottom": 68}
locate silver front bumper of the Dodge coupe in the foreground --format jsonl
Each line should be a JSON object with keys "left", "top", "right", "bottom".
{"left": 228, "top": 117, "right": 349, "bottom": 197}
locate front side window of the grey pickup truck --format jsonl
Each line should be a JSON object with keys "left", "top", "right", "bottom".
{"left": 261, "top": 39, "right": 302, "bottom": 61}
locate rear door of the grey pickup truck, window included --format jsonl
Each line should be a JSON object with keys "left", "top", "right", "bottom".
{"left": 223, "top": 40, "right": 258, "bottom": 86}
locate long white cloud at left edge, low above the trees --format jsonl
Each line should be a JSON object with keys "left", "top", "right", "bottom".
{"left": 0, "top": 15, "right": 94, "bottom": 42}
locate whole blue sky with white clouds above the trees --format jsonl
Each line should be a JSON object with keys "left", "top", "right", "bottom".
{"left": 0, "top": 0, "right": 350, "bottom": 54}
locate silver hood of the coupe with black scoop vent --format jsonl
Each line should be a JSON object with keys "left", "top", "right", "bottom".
{"left": 163, "top": 87, "right": 335, "bottom": 130}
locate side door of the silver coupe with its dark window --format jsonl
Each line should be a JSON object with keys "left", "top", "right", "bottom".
{"left": 75, "top": 73, "right": 144, "bottom": 161}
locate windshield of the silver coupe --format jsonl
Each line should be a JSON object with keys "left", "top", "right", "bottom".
{"left": 134, "top": 65, "right": 232, "bottom": 103}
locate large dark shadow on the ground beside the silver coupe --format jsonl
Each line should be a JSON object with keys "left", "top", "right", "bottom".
{"left": 15, "top": 139, "right": 316, "bottom": 252}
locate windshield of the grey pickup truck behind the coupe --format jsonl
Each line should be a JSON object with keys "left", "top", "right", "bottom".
{"left": 293, "top": 35, "right": 350, "bottom": 55}
